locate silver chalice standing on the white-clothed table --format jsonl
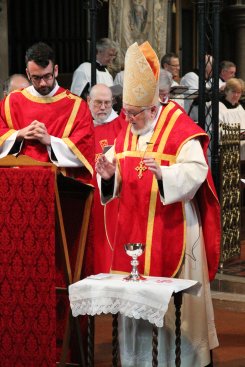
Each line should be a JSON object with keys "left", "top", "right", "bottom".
{"left": 124, "top": 243, "right": 146, "bottom": 282}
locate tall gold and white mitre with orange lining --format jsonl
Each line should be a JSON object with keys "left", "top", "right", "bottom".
{"left": 123, "top": 42, "right": 160, "bottom": 107}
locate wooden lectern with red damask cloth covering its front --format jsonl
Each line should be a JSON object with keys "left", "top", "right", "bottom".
{"left": 0, "top": 157, "right": 92, "bottom": 367}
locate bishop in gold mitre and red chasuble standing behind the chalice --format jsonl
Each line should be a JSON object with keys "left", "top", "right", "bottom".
{"left": 96, "top": 42, "right": 220, "bottom": 367}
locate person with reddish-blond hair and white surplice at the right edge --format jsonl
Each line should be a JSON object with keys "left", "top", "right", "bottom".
{"left": 219, "top": 78, "right": 245, "bottom": 160}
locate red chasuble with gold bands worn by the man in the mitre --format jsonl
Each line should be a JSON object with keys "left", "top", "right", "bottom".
{"left": 112, "top": 102, "right": 220, "bottom": 279}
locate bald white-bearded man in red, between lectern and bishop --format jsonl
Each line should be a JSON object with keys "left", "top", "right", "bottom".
{"left": 87, "top": 84, "right": 126, "bottom": 274}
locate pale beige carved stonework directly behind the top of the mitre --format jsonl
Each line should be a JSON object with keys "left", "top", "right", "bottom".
{"left": 109, "top": 0, "right": 168, "bottom": 69}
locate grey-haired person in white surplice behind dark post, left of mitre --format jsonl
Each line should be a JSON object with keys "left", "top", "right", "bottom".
{"left": 71, "top": 38, "right": 117, "bottom": 98}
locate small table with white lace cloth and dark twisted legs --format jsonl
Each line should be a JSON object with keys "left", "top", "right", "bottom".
{"left": 69, "top": 274, "right": 201, "bottom": 367}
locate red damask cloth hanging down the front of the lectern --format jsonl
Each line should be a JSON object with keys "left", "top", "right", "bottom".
{"left": 0, "top": 167, "right": 56, "bottom": 367}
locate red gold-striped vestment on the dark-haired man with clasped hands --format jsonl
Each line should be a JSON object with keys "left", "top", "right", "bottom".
{"left": 0, "top": 88, "right": 94, "bottom": 183}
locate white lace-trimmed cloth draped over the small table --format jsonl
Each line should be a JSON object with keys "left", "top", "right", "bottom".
{"left": 69, "top": 274, "right": 201, "bottom": 327}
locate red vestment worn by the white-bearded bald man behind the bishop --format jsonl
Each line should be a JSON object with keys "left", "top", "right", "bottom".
{"left": 93, "top": 117, "right": 127, "bottom": 274}
